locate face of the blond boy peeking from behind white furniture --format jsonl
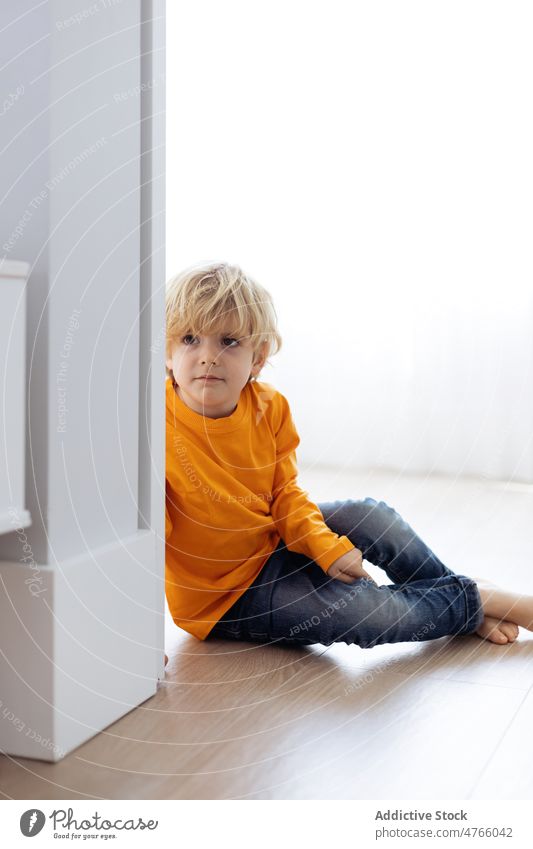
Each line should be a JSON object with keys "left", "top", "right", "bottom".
{"left": 167, "top": 331, "right": 265, "bottom": 419}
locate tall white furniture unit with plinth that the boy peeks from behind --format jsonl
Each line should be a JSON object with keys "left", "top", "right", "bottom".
{"left": 0, "top": 0, "right": 165, "bottom": 761}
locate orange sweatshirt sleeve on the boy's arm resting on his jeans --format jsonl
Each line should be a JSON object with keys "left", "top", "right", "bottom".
{"left": 271, "top": 393, "right": 355, "bottom": 572}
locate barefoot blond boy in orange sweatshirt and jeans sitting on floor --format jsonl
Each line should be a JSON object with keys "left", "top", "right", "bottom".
{"left": 165, "top": 263, "right": 533, "bottom": 648}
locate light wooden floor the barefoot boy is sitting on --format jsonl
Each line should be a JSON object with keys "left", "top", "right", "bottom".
{"left": 0, "top": 469, "right": 533, "bottom": 799}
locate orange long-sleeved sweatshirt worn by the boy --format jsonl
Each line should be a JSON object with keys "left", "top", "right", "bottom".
{"left": 165, "top": 378, "right": 354, "bottom": 640}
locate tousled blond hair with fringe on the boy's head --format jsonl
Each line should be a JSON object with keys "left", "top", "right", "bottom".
{"left": 165, "top": 262, "right": 282, "bottom": 381}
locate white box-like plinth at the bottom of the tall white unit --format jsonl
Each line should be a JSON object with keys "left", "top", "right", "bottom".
{"left": 0, "top": 530, "right": 164, "bottom": 761}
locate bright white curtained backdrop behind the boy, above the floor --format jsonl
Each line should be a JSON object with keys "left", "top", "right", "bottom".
{"left": 167, "top": 0, "right": 533, "bottom": 481}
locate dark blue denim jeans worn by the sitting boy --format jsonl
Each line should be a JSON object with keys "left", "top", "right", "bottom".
{"left": 207, "top": 498, "right": 484, "bottom": 648}
